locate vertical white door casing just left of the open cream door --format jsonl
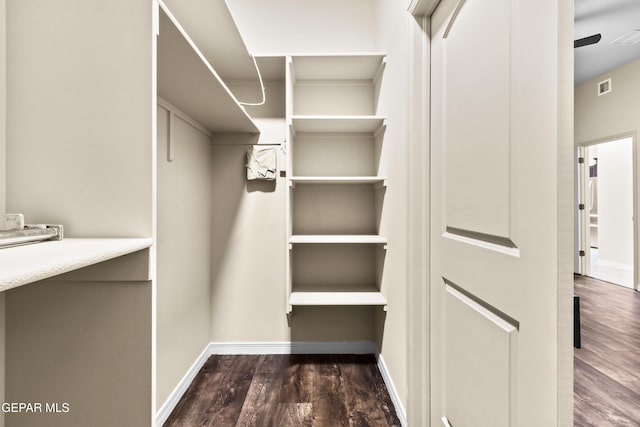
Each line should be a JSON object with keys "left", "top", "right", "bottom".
{"left": 405, "top": 10, "right": 431, "bottom": 426}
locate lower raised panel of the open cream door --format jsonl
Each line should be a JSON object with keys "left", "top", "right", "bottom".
{"left": 443, "top": 279, "right": 518, "bottom": 427}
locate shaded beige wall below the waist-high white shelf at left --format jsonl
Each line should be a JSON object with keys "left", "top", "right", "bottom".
{"left": 6, "top": 281, "right": 152, "bottom": 427}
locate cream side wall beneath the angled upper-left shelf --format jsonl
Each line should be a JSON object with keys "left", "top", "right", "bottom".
{"left": 156, "top": 107, "right": 213, "bottom": 407}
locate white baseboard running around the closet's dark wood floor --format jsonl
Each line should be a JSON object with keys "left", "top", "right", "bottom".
{"left": 156, "top": 341, "right": 407, "bottom": 427}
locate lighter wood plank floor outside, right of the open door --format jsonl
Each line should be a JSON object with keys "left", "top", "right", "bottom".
{"left": 573, "top": 276, "right": 640, "bottom": 427}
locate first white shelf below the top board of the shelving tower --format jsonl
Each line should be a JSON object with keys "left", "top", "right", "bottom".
{"left": 291, "top": 115, "right": 385, "bottom": 134}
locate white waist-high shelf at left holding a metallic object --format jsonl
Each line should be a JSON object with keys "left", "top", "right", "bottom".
{"left": 0, "top": 238, "right": 153, "bottom": 292}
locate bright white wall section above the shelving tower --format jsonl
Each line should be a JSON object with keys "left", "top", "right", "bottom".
{"left": 228, "top": 0, "right": 376, "bottom": 55}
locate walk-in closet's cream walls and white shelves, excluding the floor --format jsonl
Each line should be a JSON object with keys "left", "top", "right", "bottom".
{"left": 0, "top": 0, "right": 415, "bottom": 427}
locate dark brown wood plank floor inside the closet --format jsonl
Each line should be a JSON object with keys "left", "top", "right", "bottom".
{"left": 164, "top": 355, "right": 400, "bottom": 427}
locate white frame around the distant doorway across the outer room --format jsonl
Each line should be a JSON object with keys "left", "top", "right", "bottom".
{"left": 576, "top": 131, "right": 639, "bottom": 291}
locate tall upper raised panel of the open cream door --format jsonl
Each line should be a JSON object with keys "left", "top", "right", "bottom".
{"left": 441, "top": 0, "right": 519, "bottom": 244}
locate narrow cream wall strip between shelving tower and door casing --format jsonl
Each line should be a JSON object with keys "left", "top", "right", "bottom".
{"left": 375, "top": 0, "right": 416, "bottom": 414}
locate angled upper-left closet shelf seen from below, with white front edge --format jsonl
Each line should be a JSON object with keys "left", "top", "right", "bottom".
{"left": 158, "top": 3, "right": 259, "bottom": 133}
